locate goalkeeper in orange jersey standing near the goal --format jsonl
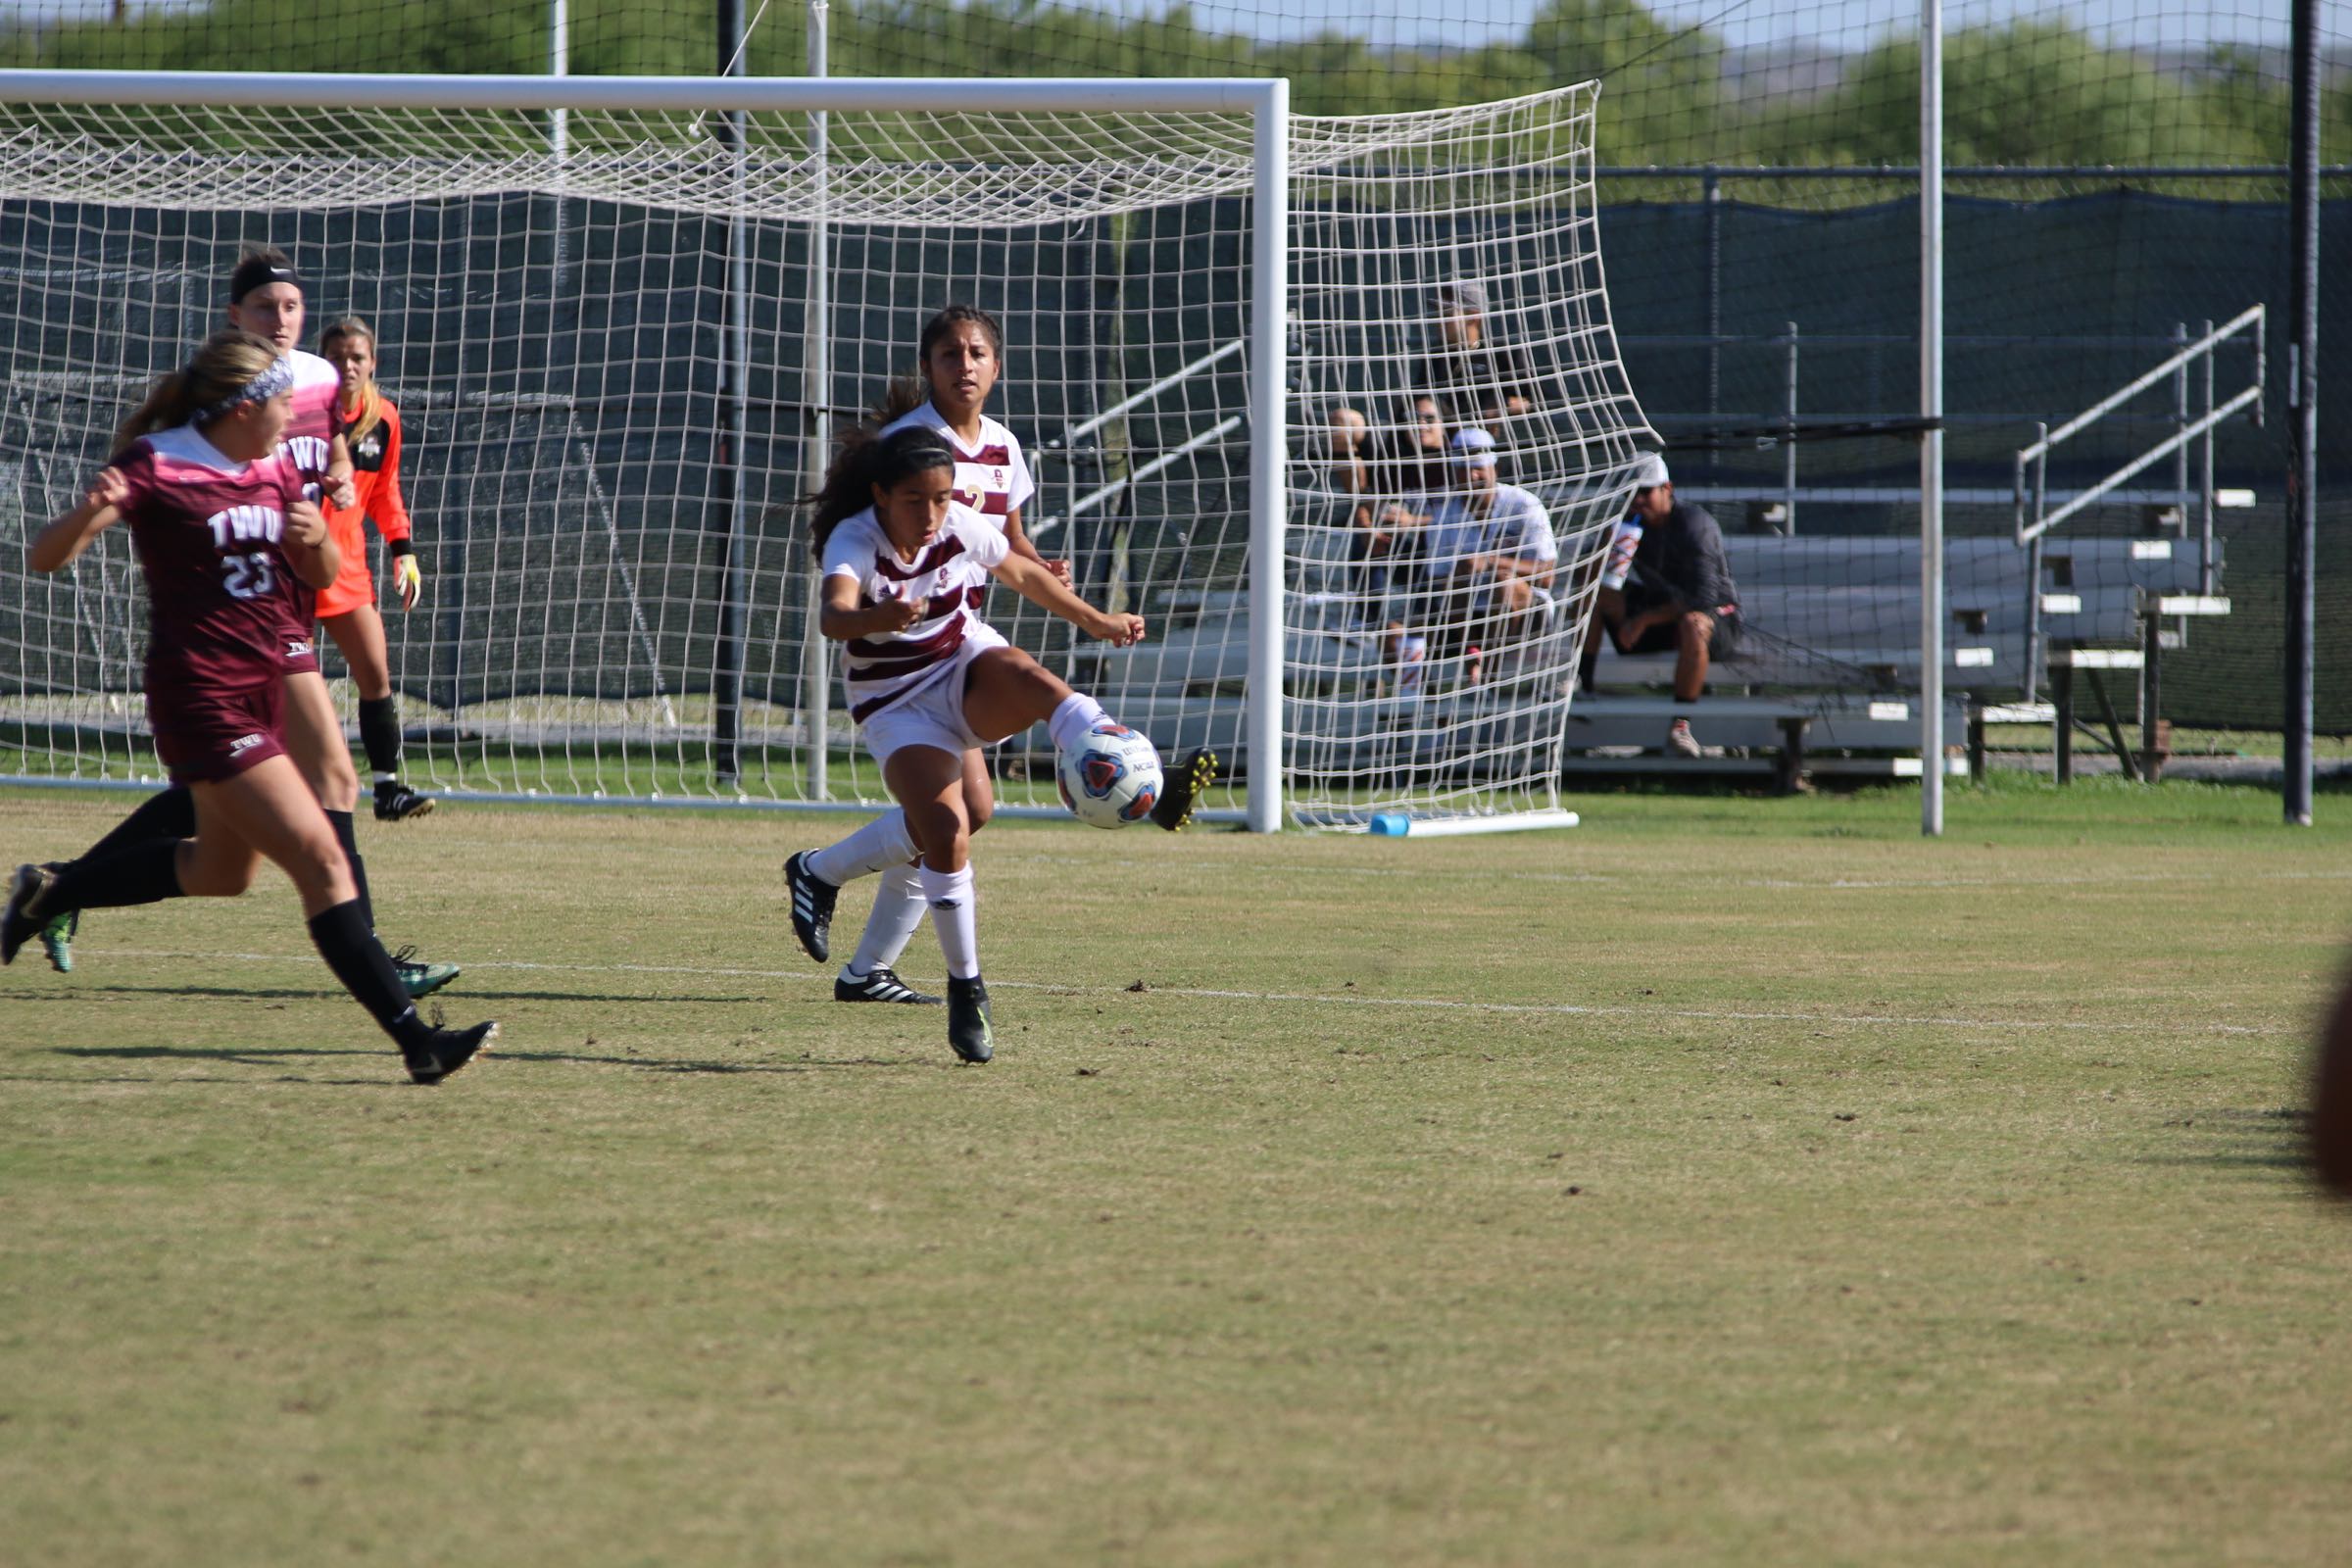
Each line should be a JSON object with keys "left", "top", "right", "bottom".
{"left": 318, "top": 315, "right": 433, "bottom": 823}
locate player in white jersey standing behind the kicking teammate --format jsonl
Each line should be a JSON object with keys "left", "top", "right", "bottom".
{"left": 786, "top": 306, "right": 1216, "bottom": 1004}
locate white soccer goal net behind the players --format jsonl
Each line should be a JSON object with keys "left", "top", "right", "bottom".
{"left": 0, "top": 75, "right": 1653, "bottom": 825}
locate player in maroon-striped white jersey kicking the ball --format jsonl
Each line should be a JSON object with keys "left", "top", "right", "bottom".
{"left": 786, "top": 428, "right": 1183, "bottom": 1062}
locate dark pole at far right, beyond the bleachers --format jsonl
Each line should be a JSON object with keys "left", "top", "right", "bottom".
{"left": 2279, "top": 0, "right": 2319, "bottom": 827}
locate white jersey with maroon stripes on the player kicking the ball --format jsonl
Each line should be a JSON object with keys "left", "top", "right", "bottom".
{"left": 825, "top": 501, "right": 1011, "bottom": 724}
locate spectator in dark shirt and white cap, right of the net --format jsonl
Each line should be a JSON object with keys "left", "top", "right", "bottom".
{"left": 1581, "top": 456, "right": 1740, "bottom": 757}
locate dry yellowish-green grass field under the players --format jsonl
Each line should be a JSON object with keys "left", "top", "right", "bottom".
{"left": 0, "top": 780, "right": 2352, "bottom": 1566}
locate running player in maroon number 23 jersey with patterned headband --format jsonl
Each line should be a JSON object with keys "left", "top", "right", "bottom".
{"left": 0, "top": 329, "right": 499, "bottom": 1084}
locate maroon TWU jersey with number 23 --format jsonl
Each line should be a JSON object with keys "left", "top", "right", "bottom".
{"left": 116, "top": 425, "right": 311, "bottom": 698}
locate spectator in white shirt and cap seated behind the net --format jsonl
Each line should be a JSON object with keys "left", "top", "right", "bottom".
{"left": 1399, "top": 425, "right": 1559, "bottom": 676}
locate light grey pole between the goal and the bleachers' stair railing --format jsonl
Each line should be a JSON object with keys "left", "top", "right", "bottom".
{"left": 1919, "top": 0, "right": 1947, "bottom": 837}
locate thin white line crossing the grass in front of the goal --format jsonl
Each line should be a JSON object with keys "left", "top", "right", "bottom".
{"left": 111, "top": 948, "right": 2286, "bottom": 1037}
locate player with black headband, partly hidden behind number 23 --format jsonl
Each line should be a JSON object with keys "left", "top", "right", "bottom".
{"left": 22, "top": 249, "right": 459, "bottom": 997}
